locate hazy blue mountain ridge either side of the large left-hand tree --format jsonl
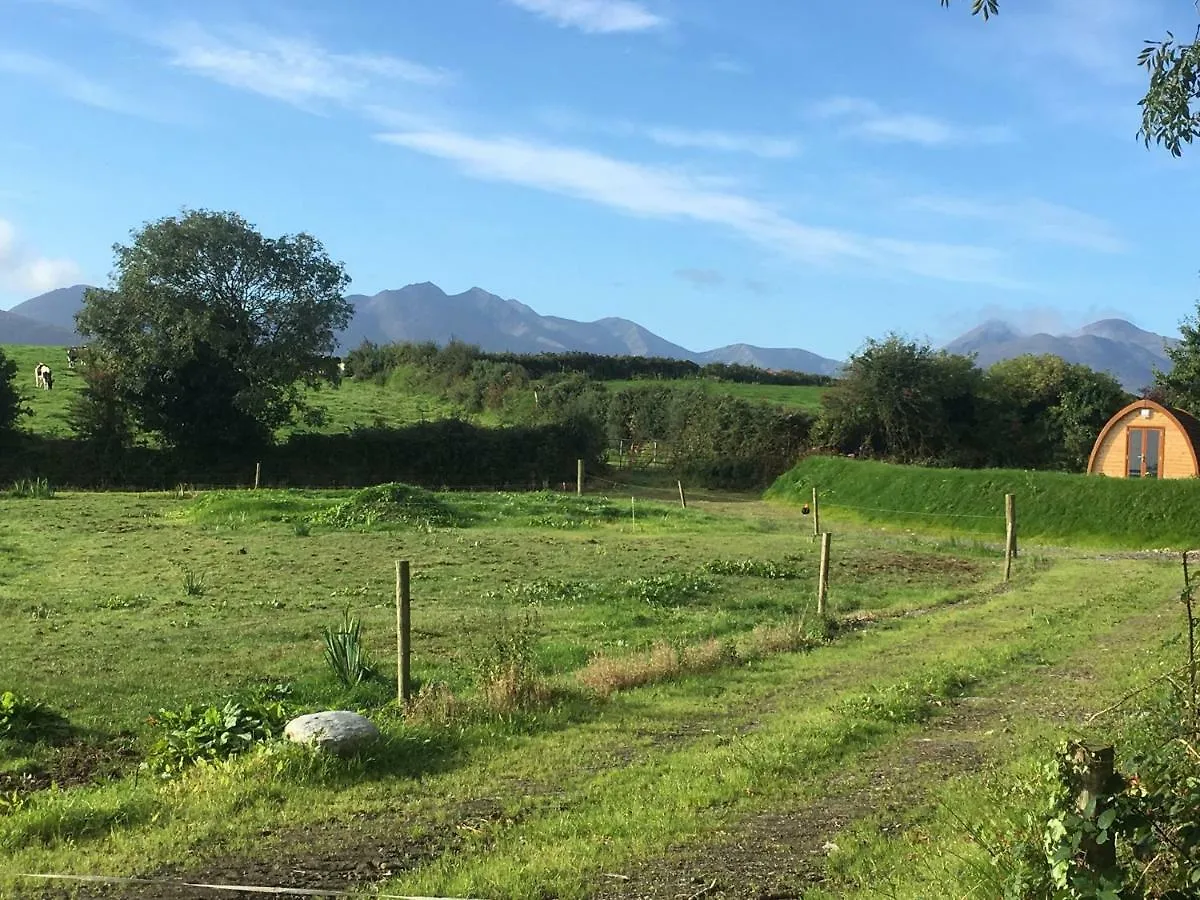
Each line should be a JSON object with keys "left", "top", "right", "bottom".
{"left": 0, "top": 282, "right": 841, "bottom": 374}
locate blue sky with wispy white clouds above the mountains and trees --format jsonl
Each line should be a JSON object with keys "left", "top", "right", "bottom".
{"left": 0, "top": 0, "right": 1200, "bottom": 358}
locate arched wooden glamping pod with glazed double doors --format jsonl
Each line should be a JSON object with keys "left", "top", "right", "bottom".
{"left": 1087, "top": 400, "right": 1200, "bottom": 478}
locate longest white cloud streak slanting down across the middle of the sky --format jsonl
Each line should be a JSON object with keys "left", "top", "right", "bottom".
{"left": 378, "top": 131, "right": 1014, "bottom": 287}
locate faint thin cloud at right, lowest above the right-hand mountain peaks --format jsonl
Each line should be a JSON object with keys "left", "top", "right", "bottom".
{"left": 907, "top": 196, "right": 1129, "bottom": 253}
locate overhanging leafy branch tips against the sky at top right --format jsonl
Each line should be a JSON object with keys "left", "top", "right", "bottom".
{"left": 941, "top": 0, "right": 1200, "bottom": 156}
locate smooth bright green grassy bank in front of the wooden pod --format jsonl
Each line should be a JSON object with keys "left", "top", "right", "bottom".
{"left": 766, "top": 456, "right": 1200, "bottom": 550}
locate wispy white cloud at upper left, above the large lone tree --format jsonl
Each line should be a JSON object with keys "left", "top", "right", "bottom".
{"left": 158, "top": 23, "right": 451, "bottom": 109}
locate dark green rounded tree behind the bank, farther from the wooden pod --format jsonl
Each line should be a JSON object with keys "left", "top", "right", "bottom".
{"left": 814, "top": 335, "right": 983, "bottom": 466}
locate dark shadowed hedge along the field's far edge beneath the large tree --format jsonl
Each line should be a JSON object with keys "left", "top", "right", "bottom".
{"left": 0, "top": 419, "right": 605, "bottom": 490}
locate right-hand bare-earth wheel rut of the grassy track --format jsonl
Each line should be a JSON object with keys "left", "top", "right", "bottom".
{"left": 590, "top": 595, "right": 1174, "bottom": 900}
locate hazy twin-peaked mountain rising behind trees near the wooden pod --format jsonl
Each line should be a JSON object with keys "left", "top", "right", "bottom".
{"left": 944, "top": 319, "right": 1178, "bottom": 391}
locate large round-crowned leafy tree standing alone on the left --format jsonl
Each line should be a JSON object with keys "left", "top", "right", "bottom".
{"left": 77, "top": 210, "right": 353, "bottom": 452}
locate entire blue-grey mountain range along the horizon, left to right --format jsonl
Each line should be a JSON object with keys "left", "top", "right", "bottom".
{"left": 0, "top": 282, "right": 1178, "bottom": 391}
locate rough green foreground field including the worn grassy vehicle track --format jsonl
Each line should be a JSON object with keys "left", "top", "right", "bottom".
{"left": 0, "top": 480, "right": 1180, "bottom": 898}
